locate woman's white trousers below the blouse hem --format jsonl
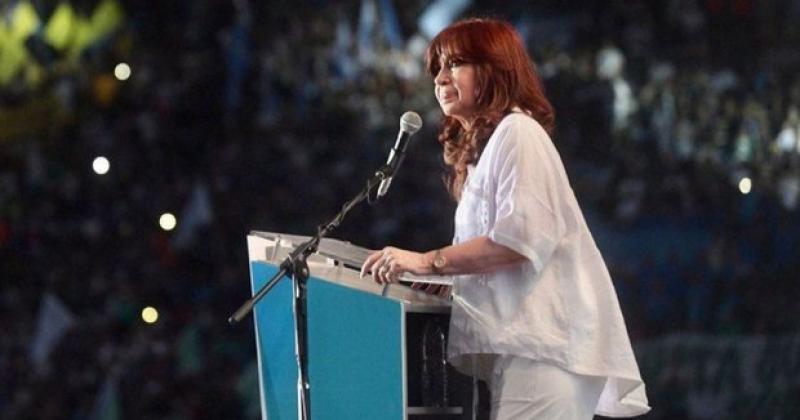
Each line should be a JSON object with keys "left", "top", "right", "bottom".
{"left": 489, "top": 356, "right": 606, "bottom": 420}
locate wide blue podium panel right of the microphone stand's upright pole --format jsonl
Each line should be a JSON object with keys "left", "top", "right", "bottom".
{"left": 308, "top": 278, "right": 404, "bottom": 420}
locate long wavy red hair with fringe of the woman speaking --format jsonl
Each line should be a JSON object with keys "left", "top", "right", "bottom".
{"left": 425, "top": 18, "right": 555, "bottom": 201}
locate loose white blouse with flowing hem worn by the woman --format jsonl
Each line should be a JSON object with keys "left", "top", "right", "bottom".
{"left": 448, "top": 113, "right": 650, "bottom": 417}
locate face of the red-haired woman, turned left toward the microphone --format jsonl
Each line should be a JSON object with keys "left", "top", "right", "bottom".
{"left": 433, "top": 55, "right": 478, "bottom": 128}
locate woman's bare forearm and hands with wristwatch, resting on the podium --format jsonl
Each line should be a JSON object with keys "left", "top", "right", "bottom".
{"left": 361, "top": 236, "right": 525, "bottom": 284}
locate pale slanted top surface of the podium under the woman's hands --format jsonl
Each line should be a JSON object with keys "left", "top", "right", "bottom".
{"left": 247, "top": 231, "right": 452, "bottom": 312}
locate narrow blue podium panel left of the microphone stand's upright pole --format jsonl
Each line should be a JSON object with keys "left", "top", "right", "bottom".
{"left": 250, "top": 262, "right": 297, "bottom": 420}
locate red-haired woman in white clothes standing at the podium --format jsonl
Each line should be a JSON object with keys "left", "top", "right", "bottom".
{"left": 362, "top": 19, "right": 649, "bottom": 419}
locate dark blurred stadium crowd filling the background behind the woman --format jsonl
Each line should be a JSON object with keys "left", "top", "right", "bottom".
{"left": 0, "top": 0, "right": 800, "bottom": 420}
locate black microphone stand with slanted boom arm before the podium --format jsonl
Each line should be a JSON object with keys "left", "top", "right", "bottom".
{"left": 228, "top": 159, "right": 399, "bottom": 420}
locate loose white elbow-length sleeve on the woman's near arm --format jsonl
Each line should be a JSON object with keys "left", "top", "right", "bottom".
{"left": 489, "top": 115, "right": 568, "bottom": 272}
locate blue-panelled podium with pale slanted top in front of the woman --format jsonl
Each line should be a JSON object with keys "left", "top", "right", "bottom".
{"left": 247, "top": 231, "right": 471, "bottom": 420}
